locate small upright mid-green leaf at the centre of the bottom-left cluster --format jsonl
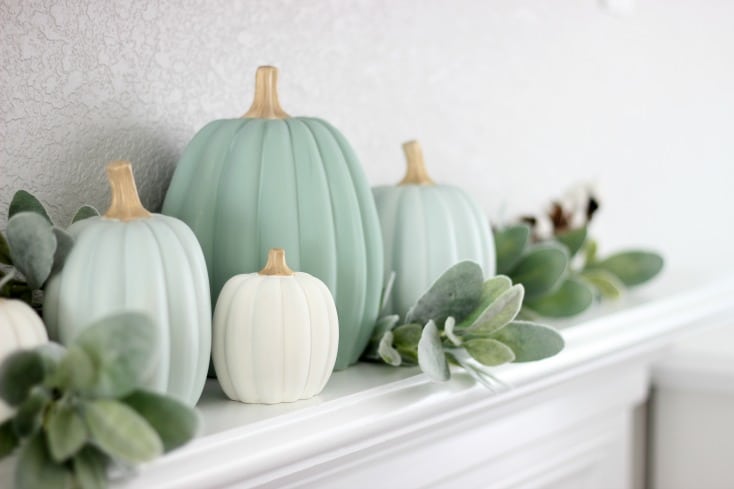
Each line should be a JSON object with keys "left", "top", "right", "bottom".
{"left": 45, "top": 402, "right": 87, "bottom": 462}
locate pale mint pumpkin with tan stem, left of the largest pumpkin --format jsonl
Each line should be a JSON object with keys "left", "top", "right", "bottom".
{"left": 44, "top": 162, "right": 211, "bottom": 406}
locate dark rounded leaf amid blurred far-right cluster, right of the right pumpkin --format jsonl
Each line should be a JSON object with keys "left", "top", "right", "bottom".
{"left": 510, "top": 243, "right": 568, "bottom": 299}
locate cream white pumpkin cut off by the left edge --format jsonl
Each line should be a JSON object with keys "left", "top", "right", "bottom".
{"left": 0, "top": 298, "right": 48, "bottom": 423}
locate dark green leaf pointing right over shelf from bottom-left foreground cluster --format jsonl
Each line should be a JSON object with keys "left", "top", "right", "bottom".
{"left": 122, "top": 390, "right": 200, "bottom": 452}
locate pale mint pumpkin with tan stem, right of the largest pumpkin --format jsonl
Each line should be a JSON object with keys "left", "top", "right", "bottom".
{"left": 373, "top": 141, "right": 495, "bottom": 317}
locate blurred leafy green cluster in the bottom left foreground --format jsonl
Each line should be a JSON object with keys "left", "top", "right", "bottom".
{"left": 0, "top": 313, "right": 198, "bottom": 489}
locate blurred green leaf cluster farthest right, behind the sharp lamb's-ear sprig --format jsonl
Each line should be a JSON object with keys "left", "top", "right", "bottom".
{"left": 494, "top": 224, "right": 663, "bottom": 318}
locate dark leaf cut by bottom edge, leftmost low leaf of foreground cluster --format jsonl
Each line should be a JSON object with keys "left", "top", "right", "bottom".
{"left": 15, "top": 434, "right": 73, "bottom": 489}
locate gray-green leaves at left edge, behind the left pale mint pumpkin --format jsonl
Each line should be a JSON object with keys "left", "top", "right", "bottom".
{"left": 0, "top": 190, "right": 98, "bottom": 309}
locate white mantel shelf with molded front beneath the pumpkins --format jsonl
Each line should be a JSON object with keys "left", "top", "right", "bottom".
{"left": 0, "top": 270, "right": 734, "bottom": 489}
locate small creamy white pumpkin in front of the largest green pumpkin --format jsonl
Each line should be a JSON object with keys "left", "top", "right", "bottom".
{"left": 212, "top": 249, "right": 339, "bottom": 404}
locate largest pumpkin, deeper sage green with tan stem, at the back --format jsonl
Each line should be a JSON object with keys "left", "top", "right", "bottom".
{"left": 163, "top": 67, "right": 383, "bottom": 369}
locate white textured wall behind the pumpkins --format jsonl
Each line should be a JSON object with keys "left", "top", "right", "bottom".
{"left": 0, "top": 0, "right": 734, "bottom": 272}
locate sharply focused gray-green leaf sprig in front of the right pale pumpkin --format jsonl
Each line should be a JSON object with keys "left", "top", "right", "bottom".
{"left": 364, "top": 261, "right": 564, "bottom": 388}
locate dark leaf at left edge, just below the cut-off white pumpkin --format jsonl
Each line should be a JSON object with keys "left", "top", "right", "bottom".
{"left": 0, "top": 350, "right": 44, "bottom": 406}
